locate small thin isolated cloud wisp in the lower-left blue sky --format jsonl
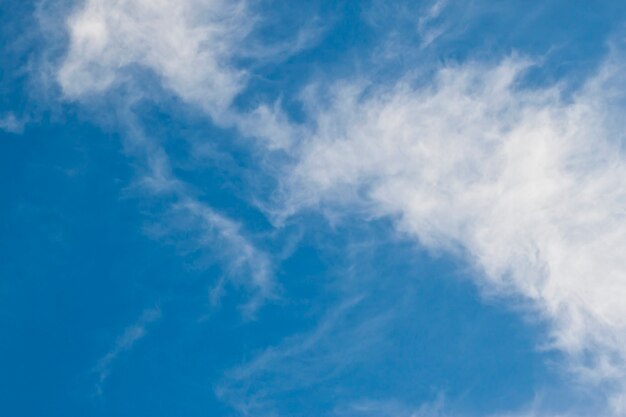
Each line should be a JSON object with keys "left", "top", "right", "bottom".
{"left": 94, "top": 308, "right": 161, "bottom": 394}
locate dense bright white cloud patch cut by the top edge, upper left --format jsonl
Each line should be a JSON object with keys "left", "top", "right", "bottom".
{"left": 58, "top": 0, "right": 251, "bottom": 115}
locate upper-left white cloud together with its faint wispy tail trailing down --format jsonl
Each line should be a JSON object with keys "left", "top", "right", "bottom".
{"left": 56, "top": 0, "right": 276, "bottom": 310}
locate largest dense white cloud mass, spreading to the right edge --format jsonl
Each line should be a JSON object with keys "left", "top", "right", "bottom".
{"left": 284, "top": 59, "right": 626, "bottom": 413}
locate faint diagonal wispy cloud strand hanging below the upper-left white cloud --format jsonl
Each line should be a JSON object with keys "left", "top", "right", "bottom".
{"left": 121, "top": 111, "right": 275, "bottom": 318}
